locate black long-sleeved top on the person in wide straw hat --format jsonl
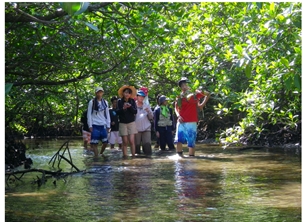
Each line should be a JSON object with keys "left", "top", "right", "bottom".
{"left": 116, "top": 98, "right": 137, "bottom": 123}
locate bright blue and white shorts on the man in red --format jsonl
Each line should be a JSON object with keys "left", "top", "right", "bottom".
{"left": 174, "top": 122, "right": 197, "bottom": 148}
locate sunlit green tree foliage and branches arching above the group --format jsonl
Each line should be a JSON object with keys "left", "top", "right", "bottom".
{"left": 5, "top": 2, "right": 302, "bottom": 147}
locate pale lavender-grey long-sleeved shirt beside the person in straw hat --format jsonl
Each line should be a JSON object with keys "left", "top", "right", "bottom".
{"left": 135, "top": 105, "right": 153, "bottom": 132}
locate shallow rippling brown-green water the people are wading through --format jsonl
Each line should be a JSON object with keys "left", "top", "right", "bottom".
{"left": 5, "top": 140, "right": 301, "bottom": 222}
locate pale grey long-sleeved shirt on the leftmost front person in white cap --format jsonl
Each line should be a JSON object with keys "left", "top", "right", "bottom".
{"left": 87, "top": 100, "right": 111, "bottom": 128}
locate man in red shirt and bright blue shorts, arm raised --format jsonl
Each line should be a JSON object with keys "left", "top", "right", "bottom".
{"left": 174, "top": 77, "right": 210, "bottom": 156}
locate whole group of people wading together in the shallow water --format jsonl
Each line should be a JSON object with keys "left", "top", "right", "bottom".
{"left": 81, "top": 77, "right": 210, "bottom": 158}
